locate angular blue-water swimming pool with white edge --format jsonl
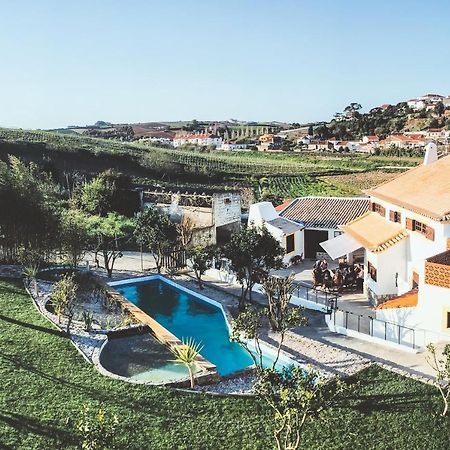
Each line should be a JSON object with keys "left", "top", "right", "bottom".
{"left": 110, "top": 275, "right": 293, "bottom": 376}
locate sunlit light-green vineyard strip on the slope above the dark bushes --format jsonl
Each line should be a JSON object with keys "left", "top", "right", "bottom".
{"left": 0, "top": 129, "right": 372, "bottom": 177}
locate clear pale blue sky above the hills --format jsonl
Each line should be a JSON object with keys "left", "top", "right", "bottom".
{"left": 0, "top": 0, "right": 450, "bottom": 128}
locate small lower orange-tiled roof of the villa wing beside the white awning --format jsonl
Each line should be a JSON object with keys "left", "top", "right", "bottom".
{"left": 340, "top": 212, "right": 408, "bottom": 253}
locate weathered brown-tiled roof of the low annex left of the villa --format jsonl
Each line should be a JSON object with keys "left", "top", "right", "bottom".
{"left": 280, "top": 197, "right": 369, "bottom": 229}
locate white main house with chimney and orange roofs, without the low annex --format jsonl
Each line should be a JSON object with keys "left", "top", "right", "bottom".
{"left": 325, "top": 144, "right": 450, "bottom": 345}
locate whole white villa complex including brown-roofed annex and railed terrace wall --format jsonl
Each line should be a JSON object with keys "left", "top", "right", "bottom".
{"left": 249, "top": 144, "right": 450, "bottom": 350}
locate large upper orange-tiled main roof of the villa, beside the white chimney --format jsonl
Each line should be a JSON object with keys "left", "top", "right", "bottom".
{"left": 366, "top": 155, "right": 450, "bottom": 221}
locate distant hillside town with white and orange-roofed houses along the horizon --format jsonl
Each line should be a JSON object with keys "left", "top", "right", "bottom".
{"left": 53, "top": 94, "right": 450, "bottom": 154}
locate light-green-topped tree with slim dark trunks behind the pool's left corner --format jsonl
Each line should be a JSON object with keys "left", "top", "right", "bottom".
{"left": 88, "top": 213, "right": 134, "bottom": 278}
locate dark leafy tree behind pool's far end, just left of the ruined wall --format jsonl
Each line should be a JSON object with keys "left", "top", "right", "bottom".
{"left": 134, "top": 208, "right": 179, "bottom": 273}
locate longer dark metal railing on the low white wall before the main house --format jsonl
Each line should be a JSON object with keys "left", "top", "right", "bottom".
{"left": 333, "top": 308, "right": 417, "bottom": 349}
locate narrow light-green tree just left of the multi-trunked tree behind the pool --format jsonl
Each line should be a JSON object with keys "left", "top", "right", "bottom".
{"left": 60, "top": 208, "right": 89, "bottom": 267}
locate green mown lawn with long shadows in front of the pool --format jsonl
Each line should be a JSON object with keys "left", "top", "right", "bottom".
{"left": 0, "top": 280, "right": 450, "bottom": 450}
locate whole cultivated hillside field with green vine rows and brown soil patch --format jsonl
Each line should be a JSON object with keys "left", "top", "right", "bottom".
{"left": 0, "top": 128, "right": 420, "bottom": 207}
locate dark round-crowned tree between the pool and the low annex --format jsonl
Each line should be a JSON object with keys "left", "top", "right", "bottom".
{"left": 223, "top": 226, "right": 284, "bottom": 311}
